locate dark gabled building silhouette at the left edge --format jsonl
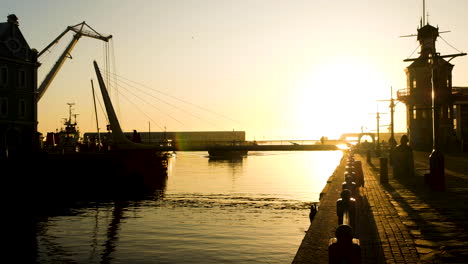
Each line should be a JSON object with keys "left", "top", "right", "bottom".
{"left": 0, "top": 14, "right": 38, "bottom": 159}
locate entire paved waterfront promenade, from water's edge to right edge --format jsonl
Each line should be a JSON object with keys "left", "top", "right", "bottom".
{"left": 293, "top": 152, "right": 468, "bottom": 264}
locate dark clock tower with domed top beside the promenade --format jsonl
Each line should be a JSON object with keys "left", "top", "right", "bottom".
{"left": 397, "top": 21, "right": 468, "bottom": 151}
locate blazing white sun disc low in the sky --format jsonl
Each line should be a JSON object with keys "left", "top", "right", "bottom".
{"left": 293, "top": 55, "right": 390, "bottom": 138}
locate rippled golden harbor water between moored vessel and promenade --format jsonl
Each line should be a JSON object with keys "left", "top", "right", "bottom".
{"left": 35, "top": 151, "right": 342, "bottom": 264}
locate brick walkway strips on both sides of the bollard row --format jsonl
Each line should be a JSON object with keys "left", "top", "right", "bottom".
{"left": 292, "top": 153, "right": 418, "bottom": 264}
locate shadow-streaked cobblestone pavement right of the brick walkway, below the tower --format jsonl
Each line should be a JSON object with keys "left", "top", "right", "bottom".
{"left": 385, "top": 151, "right": 468, "bottom": 263}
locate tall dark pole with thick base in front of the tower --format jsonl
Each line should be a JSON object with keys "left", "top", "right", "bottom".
{"left": 428, "top": 54, "right": 445, "bottom": 191}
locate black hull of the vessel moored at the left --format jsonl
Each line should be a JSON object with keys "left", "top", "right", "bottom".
{"left": 8, "top": 151, "right": 168, "bottom": 202}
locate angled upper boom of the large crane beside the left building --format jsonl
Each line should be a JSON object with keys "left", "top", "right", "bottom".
{"left": 36, "top": 21, "right": 112, "bottom": 101}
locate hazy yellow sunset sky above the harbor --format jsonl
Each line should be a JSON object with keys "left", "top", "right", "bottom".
{"left": 0, "top": 0, "right": 468, "bottom": 140}
